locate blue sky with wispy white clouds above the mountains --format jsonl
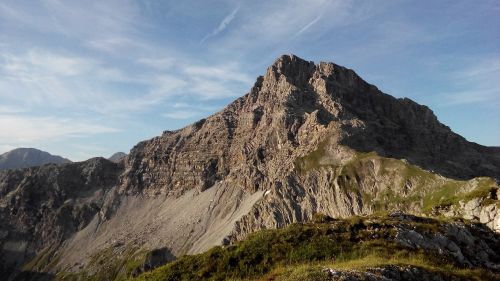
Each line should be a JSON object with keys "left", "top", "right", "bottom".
{"left": 0, "top": 0, "right": 500, "bottom": 160}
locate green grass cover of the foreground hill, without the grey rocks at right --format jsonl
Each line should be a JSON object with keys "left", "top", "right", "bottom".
{"left": 132, "top": 217, "right": 493, "bottom": 280}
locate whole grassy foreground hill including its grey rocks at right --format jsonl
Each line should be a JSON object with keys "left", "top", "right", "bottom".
{"left": 122, "top": 213, "right": 500, "bottom": 280}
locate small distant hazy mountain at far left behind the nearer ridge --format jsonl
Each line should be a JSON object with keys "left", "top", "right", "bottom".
{"left": 0, "top": 148, "right": 71, "bottom": 170}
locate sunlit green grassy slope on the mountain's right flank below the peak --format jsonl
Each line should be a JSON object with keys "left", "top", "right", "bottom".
{"left": 295, "top": 142, "right": 498, "bottom": 213}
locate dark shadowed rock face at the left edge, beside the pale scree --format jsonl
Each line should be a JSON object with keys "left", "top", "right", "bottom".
{"left": 0, "top": 158, "right": 122, "bottom": 276}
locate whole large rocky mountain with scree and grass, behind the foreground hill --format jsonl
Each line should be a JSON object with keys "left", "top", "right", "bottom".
{"left": 0, "top": 55, "right": 500, "bottom": 280}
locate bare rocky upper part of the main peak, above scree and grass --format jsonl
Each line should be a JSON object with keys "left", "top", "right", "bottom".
{"left": 118, "top": 55, "right": 500, "bottom": 198}
